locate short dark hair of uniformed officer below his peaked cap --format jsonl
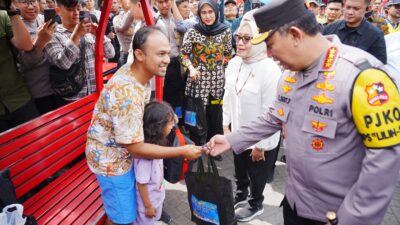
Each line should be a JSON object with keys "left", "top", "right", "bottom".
{"left": 277, "top": 13, "right": 320, "bottom": 36}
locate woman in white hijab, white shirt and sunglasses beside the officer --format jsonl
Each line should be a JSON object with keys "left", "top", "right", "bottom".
{"left": 223, "top": 15, "right": 282, "bottom": 222}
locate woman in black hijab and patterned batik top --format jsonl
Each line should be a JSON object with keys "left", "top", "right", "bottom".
{"left": 181, "top": 0, "right": 232, "bottom": 145}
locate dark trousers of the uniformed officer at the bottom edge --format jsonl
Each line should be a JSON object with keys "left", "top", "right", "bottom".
{"left": 281, "top": 197, "right": 326, "bottom": 225}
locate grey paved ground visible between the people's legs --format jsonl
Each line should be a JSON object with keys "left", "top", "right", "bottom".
{"left": 164, "top": 149, "right": 400, "bottom": 225}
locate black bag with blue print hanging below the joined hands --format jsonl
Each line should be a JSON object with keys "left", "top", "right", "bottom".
{"left": 185, "top": 156, "right": 237, "bottom": 225}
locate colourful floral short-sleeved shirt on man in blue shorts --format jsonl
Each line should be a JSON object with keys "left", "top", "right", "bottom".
{"left": 86, "top": 64, "right": 151, "bottom": 176}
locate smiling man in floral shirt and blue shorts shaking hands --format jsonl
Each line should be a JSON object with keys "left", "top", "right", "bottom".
{"left": 86, "top": 27, "right": 201, "bottom": 224}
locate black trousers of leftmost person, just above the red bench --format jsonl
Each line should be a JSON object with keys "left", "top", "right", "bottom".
{"left": 0, "top": 100, "right": 39, "bottom": 133}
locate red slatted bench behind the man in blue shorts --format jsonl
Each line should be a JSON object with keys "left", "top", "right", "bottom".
{"left": 0, "top": 94, "right": 105, "bottom": 224}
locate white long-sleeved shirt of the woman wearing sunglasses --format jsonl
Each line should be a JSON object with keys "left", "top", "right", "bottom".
{"left": 223, "top": 56, "right": 282, "bottom": 150}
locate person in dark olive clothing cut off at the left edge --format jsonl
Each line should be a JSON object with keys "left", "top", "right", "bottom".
{"left": 0, "top": 0, "right": 38, "bottom": 132}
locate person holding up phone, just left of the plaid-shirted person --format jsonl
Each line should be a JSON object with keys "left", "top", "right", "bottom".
{"left": 16, "top": 0, "right": 61, "bottom": 114}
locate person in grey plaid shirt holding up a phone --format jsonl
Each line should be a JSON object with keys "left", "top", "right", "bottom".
{"left": 45, "top": 0, "right": 115, "bottom": 102}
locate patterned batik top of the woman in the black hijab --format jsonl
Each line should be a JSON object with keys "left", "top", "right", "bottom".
{"left": 181, "top": 28, "right": 232, "bottom": 105}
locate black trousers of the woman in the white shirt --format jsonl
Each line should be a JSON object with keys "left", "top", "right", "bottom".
{"left": 233, "top": 141, "right": 280, "bottom": 207}
